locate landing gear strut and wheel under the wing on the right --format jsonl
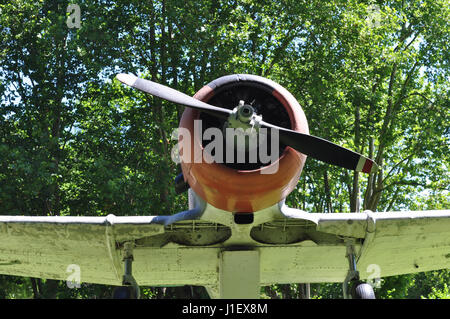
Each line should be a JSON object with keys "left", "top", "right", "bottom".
{"left": 342, "top": 239, "right": 375, "bottom": 299}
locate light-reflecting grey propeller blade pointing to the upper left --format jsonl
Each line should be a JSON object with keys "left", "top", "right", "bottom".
{"left": 116, "top": 73, "right": 231, "bottom": 119}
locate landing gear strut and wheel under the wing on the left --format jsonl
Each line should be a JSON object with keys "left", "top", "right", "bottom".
{"left": 113, "top": 242, "right": 140, "bottom": 299}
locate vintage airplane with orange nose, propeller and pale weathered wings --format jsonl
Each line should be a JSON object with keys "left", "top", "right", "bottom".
{"left": 0, "top": 74, "right": 450, "bottom": 299}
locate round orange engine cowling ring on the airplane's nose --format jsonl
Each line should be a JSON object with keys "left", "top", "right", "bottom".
{"left": 178, "top": 74, "right": 309, "bottom": 213}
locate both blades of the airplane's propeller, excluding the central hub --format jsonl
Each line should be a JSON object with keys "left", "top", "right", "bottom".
{"left": 116, "top": 73, "right": 378, "bottom": 173}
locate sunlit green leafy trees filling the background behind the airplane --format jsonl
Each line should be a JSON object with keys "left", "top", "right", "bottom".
{"left": 0, "top": 0, "right": 450, "bottom": 298}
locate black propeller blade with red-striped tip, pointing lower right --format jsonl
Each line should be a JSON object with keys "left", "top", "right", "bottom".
{"left": 260, "top": 121, "right": 378, "bottom": 173}
